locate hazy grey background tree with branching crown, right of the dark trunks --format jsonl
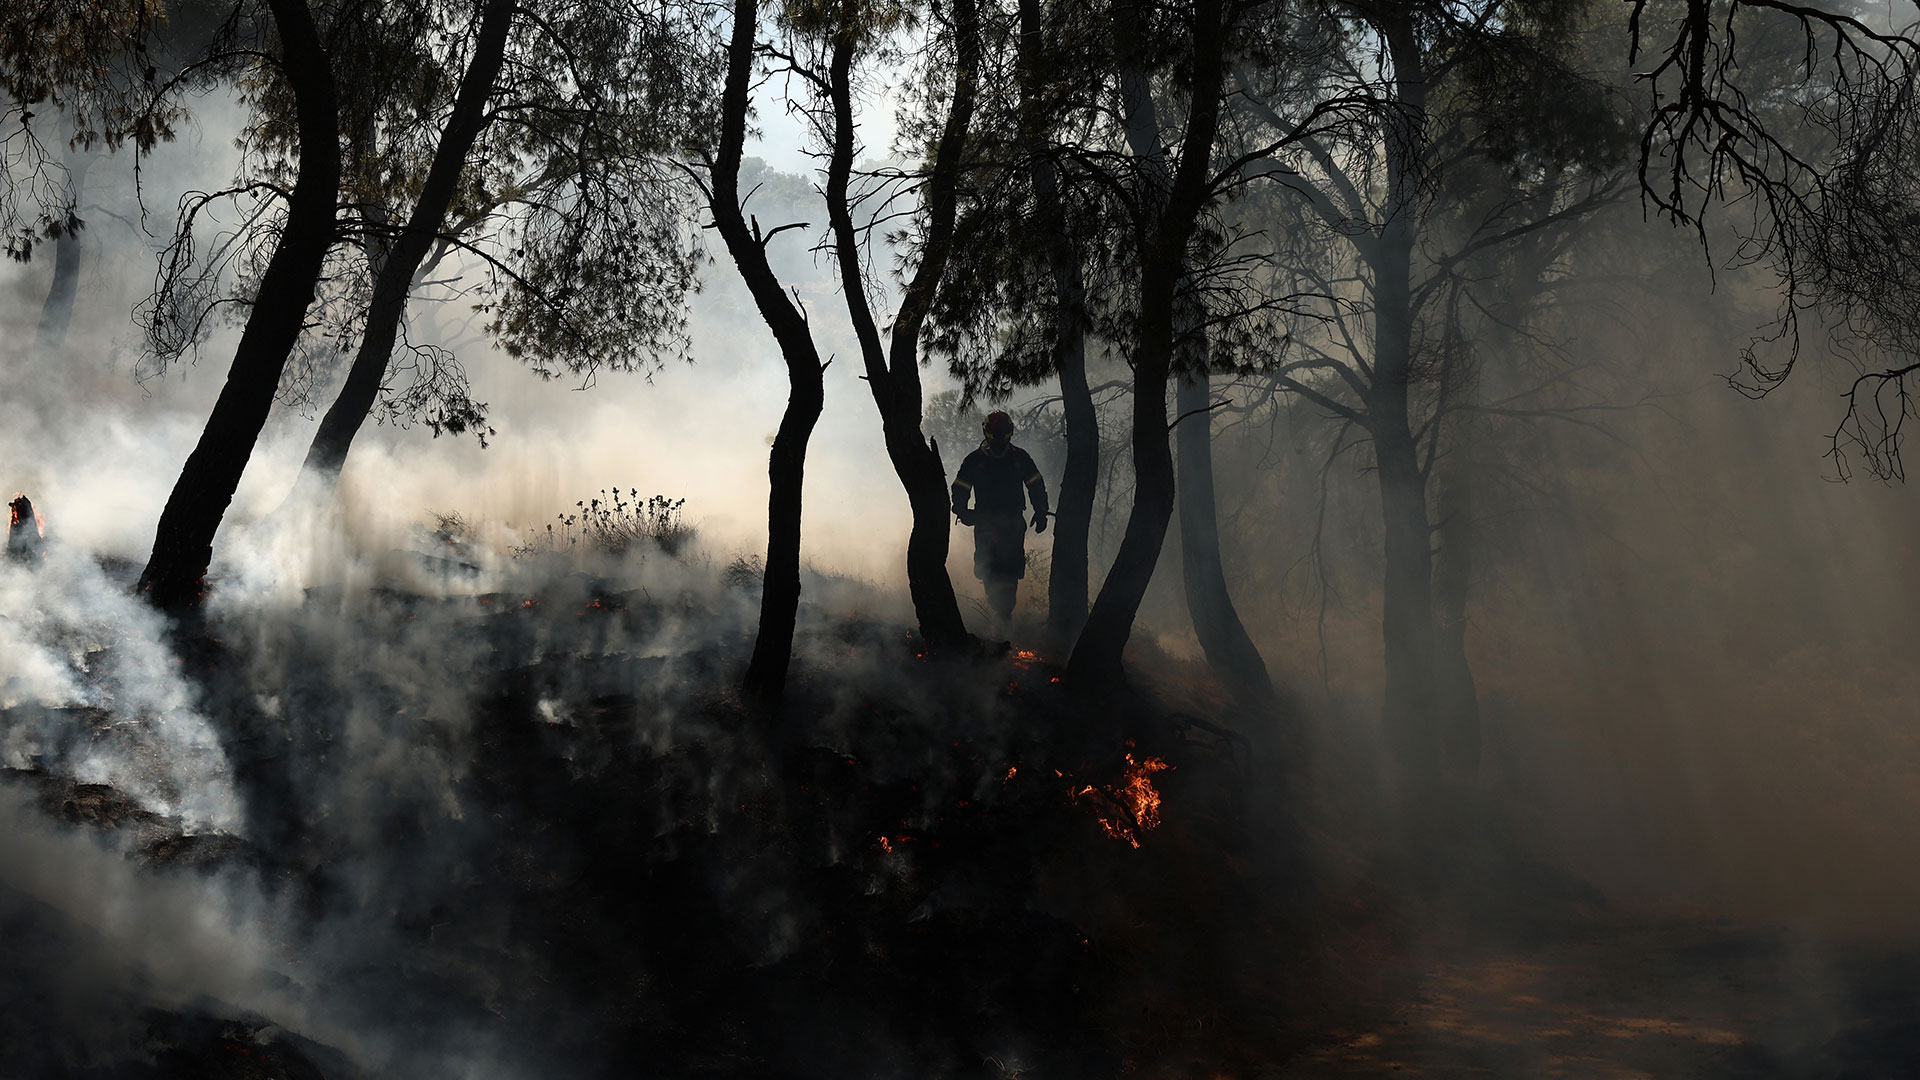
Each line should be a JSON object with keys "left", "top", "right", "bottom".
{"left": 1240, "top": 4, "right": 1620, "bottom": 790}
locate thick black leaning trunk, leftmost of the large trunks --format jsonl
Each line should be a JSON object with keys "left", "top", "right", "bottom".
{"left": 138, "top": 0, "right": 340, "bottom": 609}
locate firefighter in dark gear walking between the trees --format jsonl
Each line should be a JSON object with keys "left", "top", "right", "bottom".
{"left": 952, "top": 411, "right": 1046, "bottom": 621}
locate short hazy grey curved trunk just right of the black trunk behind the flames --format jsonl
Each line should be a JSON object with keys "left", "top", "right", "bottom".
{"left": 1173, "top": 365, "right": 1273, "bottom": 698}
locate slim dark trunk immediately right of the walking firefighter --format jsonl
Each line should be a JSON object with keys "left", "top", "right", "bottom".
{"left": 1020, "top": 0, "right": 1100, "bottom": 642}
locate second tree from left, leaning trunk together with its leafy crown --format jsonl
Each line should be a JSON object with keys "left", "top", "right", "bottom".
{"left": 278, "top": 0, "right": 710, "bottom": 500}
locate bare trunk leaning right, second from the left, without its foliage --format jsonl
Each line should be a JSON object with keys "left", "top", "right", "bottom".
{"left": 280, "top": 0, "right": 515, "bottom": 505}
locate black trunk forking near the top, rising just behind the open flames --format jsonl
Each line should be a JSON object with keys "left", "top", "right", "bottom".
{"left": 1068, "top": 0, "right": 1227, "bottom": 688}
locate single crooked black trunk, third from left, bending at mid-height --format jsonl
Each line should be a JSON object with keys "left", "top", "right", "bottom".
{"left": 708, "top": 0, "right": 826, "bottom": 707}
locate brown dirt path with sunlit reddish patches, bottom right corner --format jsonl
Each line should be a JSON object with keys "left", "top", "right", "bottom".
{"left": 1279, "top": 924, "right": 1920, "bottom": 1080}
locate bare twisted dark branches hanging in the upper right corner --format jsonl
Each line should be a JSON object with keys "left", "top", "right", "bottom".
{"left": 1630, "top": 0, "right": 1920, "bottom": 479}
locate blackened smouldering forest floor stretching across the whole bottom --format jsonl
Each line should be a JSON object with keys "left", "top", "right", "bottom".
{"left": 4, "top": 557, "right": 1920, "bottom": 1078}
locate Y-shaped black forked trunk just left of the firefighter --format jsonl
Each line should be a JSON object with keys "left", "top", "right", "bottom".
{"left": 826, "top": 0, "right": 979, "bottom": 650}
